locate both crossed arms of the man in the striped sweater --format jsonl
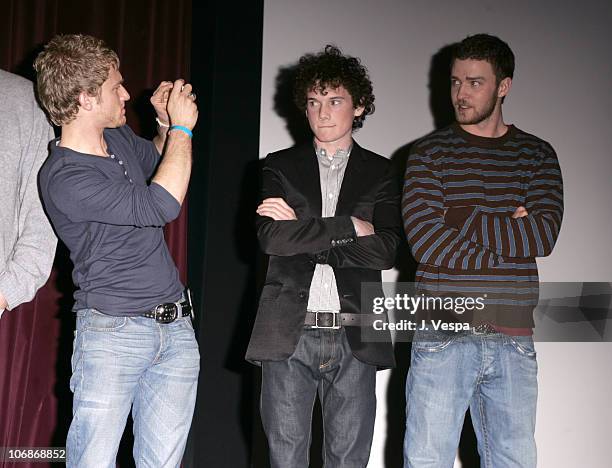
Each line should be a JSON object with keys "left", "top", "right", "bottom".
{"left": 402, "top": 149, "right": 563, "bottom": 270}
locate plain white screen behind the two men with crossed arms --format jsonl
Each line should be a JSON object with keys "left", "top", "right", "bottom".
{"left": 260, "top": 0, "right": 612, "bottom": 468}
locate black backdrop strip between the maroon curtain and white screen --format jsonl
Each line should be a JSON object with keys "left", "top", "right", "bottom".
{"left": 184, "top": 0, "right": 265, "bottom": 468}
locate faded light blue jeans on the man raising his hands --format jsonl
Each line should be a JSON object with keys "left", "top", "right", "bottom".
{"left": 66, "top": 309, "right": 200, "bottom": 468}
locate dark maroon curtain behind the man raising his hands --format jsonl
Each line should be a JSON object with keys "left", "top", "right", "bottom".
{"left": 0, "top": 0, "right": 191, "bottom": 467}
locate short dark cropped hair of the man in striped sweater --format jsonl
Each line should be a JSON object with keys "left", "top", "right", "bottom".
{"left": 451, "top": 34, "right": 514, "bottom": 84}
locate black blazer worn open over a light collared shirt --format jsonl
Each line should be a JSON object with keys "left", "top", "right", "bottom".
{"left": 246, "top": 143, "right": 402, "bottom": 367}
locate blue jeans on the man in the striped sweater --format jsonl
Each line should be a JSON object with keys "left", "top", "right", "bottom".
{"left": 404, "top": 331, "right": 538, "bottom": 468}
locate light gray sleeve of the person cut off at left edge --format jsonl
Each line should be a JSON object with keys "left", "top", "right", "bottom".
{"left": 0, "top": 99, "right": 57, "bottom": 309}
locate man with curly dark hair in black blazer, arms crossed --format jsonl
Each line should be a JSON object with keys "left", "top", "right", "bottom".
{"left": 246, "top": 46, "right": 401, "bottom": 468}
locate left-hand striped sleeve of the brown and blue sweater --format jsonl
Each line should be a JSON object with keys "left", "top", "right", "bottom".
{"left": 402, "top": 151, "right": 499, "bottom": 270}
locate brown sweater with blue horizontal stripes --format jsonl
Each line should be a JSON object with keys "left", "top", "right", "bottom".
{"left": 402, "top": 123, "right": 563, "bottom": 328}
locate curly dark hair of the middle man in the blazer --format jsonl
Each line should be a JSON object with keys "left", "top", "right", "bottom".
{"left": 293, "top": 45, "right": 374, "bottom": 130}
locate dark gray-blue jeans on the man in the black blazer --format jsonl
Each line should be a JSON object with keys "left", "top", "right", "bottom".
{"left": 261, "top": 328, "right": 376, "bottom": 468}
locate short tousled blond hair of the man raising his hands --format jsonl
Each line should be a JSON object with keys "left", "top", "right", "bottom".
{"left": 34, "top": 34, "right": 119, "bottom": 126}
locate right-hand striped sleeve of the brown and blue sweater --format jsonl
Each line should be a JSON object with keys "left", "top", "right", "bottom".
{"left": 464, "top": 146, "right": 563, "bottom": 258}
